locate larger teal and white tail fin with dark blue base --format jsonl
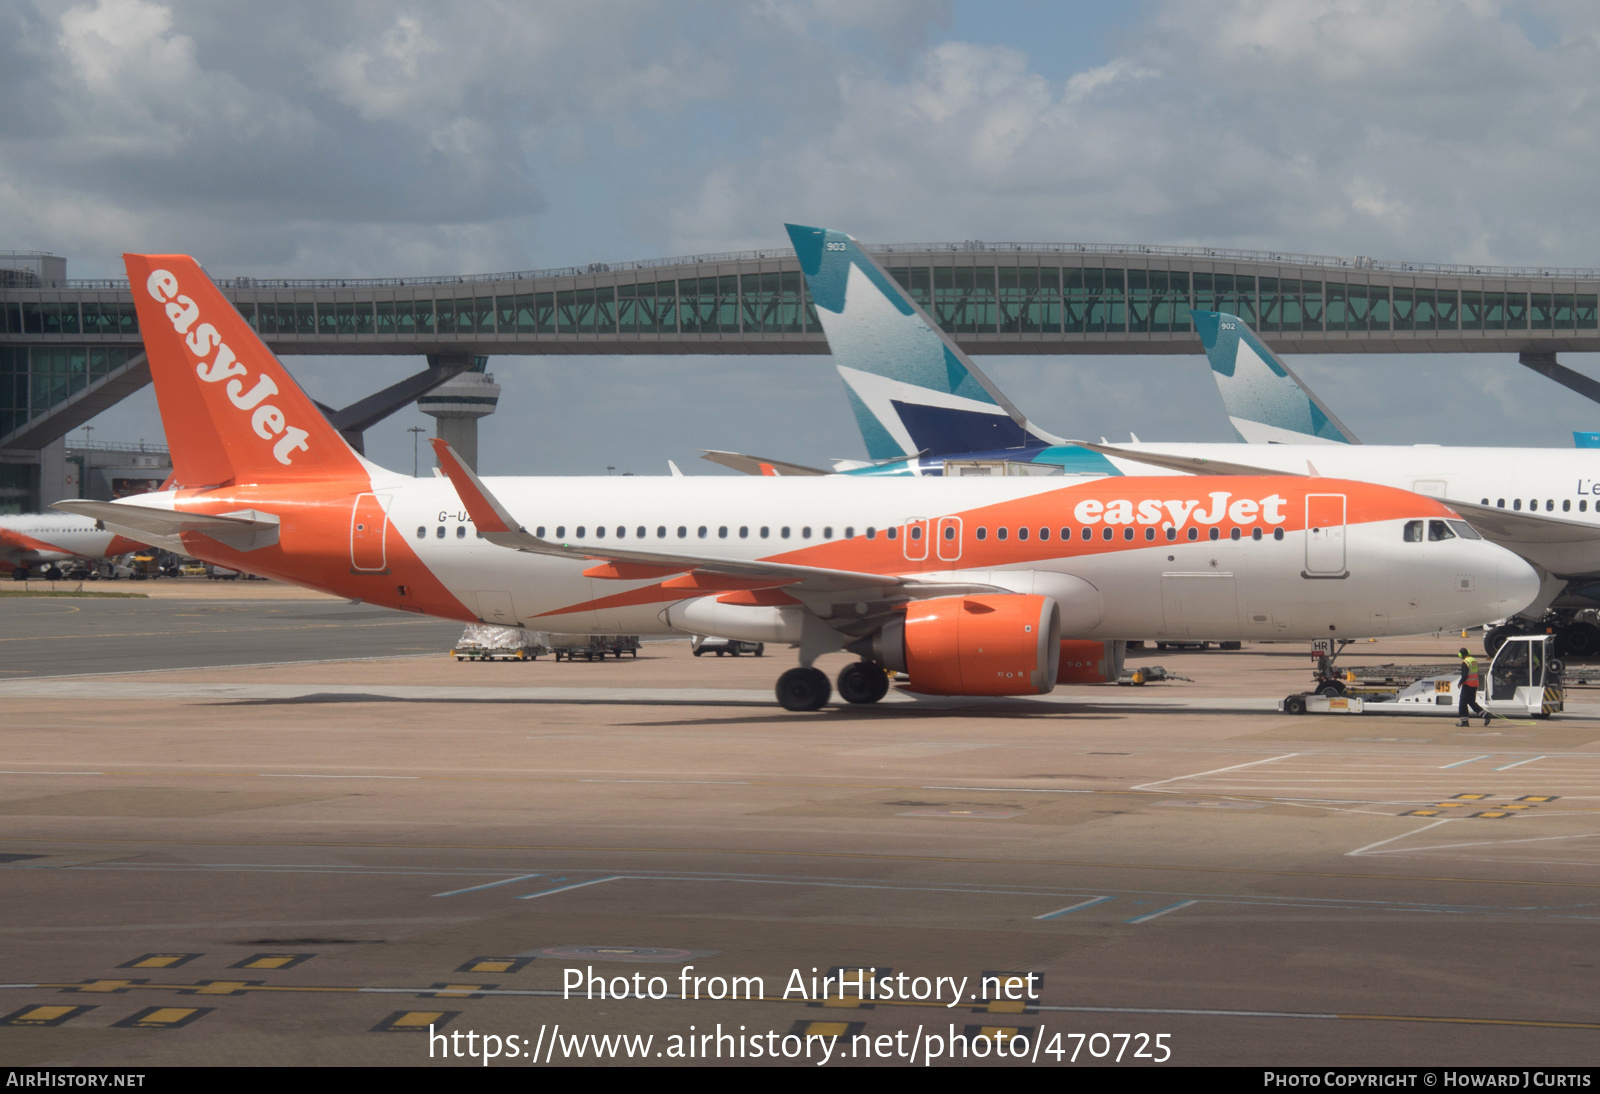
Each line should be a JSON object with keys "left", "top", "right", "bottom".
{"left": 784, "top": 224, "right": 1061, "bottom": 459}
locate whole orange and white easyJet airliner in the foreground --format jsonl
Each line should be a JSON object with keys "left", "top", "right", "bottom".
{"left": 58, "top": 254, "right": 1538, "bottom": 710}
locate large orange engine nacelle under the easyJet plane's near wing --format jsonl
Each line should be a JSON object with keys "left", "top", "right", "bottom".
{"left": 874, "top": 593, "right": 1061, "bottom": 696}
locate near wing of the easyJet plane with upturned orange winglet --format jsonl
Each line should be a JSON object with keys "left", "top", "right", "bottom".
{"left": 430, "top": 438, "right": 1003, "bottom": 597}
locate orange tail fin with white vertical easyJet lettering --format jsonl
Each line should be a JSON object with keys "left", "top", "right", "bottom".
{"left": 122, "top": 254, "right": 365, "bottom": 486}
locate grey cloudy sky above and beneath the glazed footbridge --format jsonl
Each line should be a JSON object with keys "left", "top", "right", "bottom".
{"left": 0, "top": 0, "right": 1600, "bottom": 473}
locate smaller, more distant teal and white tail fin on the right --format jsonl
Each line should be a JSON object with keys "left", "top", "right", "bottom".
{"left": 1190, "top": 312, "right": 1362, "bottom": 445}
